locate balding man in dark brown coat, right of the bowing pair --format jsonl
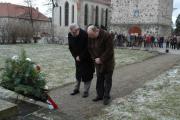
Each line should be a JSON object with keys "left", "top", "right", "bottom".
{"left": 88, "top": 25, "right": 115, "bottom": 105}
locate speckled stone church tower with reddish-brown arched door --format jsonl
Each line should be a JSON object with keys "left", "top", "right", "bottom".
{"left": 110, "top": 0, "right": 173, "bottom": 36}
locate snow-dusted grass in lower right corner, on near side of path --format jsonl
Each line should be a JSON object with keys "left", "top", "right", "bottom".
{"left": 93, "top": 65, "right": 180, "bottom": 120}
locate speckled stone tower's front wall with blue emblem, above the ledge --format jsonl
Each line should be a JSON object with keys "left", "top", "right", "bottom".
{"left": 111, "top": 0, "right": 158, "bottom": 24}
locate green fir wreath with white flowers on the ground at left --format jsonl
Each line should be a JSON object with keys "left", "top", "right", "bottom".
{"left": 0, "top": 50, "right": 47, "bottom": 101}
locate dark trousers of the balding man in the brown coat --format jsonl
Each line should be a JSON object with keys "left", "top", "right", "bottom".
{"left": 96, "top": 72, "right": 113, "bottom": 98}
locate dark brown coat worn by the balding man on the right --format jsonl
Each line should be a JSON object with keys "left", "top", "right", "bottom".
{"left": 88, "top": 29, "right": 115, "bottom": 73}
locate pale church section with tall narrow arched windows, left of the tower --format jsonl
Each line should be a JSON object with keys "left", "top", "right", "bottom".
{"left": 53, "top": 0, "right": 111, "bottom": 37}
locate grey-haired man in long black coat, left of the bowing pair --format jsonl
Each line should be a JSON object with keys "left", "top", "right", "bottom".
{"left": 68, "top": 24, "right": 94, "bottom": 97}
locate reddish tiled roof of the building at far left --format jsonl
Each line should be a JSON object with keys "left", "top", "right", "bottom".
{"left": 0, "top": 3, "right": 49, "bottom": 21}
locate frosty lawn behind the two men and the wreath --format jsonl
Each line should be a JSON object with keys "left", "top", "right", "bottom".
{"left": 0, "top": 44, "right": 155, "bottom": 88}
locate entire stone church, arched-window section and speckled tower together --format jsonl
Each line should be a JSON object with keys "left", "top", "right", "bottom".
{"left": 53, "top": 0, "right": 173, "bottom": 36}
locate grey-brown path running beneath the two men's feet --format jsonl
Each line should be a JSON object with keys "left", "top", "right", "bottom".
{"left": 22, "top": 54, "right": 180, "bottom": 120}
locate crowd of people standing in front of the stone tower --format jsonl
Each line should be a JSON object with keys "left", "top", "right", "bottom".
{"left": 111, "top": 33, "right": 180, "bottom": 50}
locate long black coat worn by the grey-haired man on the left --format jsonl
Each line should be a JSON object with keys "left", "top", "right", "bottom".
{"left": 68, "top": 29, "right": 94, "bottom": 82}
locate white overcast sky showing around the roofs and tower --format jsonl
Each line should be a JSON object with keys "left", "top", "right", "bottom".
{"left": 0, "top": 0, "right": 180, "bottom": 22}
